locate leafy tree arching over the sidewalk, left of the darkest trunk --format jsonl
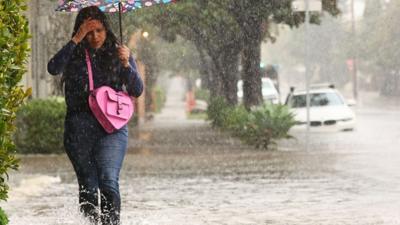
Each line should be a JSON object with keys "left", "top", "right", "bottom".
{"left": 127, "top": 0, "right": 241, "bottom": 105}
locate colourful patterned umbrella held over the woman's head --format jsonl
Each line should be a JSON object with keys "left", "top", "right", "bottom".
{"left": 56, "top": 0, "right": 177, "bottom": 43}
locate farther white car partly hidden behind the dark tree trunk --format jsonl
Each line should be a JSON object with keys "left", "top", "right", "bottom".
{"left": 237, "top": 78, "right": 280, "bottom": 104}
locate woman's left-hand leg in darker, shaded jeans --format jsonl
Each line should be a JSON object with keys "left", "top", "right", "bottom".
{"left": 64, "top": 115, "right": 103, "bottom": 224}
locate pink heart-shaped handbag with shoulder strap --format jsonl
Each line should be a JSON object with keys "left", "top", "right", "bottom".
{"left": 85, "top": 49, "right": 134, "bottom": 133}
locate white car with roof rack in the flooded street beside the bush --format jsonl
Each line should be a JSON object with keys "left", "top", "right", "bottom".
{"left": 285, "top": 85, "right": 356, "bottom": 132}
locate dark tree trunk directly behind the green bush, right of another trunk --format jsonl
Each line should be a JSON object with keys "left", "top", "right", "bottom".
{"left": 242, "top": 26, "right": 262, "bottom": 109}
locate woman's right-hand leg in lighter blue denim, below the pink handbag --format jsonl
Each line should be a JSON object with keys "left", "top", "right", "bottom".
{"left": 94, "top": 126, "right": 128, "bottom": 225}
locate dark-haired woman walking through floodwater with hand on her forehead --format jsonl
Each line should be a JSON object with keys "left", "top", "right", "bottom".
{"left": 48, "top": 6, "right": 143, "bottom": 225}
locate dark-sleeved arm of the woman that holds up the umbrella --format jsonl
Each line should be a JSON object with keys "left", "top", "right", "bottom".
{"left": 120, "top": 56, "right": 143, "bottom": 97}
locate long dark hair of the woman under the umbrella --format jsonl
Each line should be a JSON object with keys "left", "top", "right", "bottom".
{"left": 61, "top": 6, "right": 119, "bottom": 91}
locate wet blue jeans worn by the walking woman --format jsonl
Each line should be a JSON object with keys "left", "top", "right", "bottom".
{"left": 64, "top": 113, "right": 128, "bottom": 225}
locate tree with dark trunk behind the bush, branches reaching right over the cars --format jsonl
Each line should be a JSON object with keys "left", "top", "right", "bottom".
{"left": 220, "top": 0, "right": 339, "bottom": 108}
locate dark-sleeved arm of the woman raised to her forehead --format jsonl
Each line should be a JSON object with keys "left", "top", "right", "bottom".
{"left": 47, "top": 41, "right": 76, "bottom": 75}
